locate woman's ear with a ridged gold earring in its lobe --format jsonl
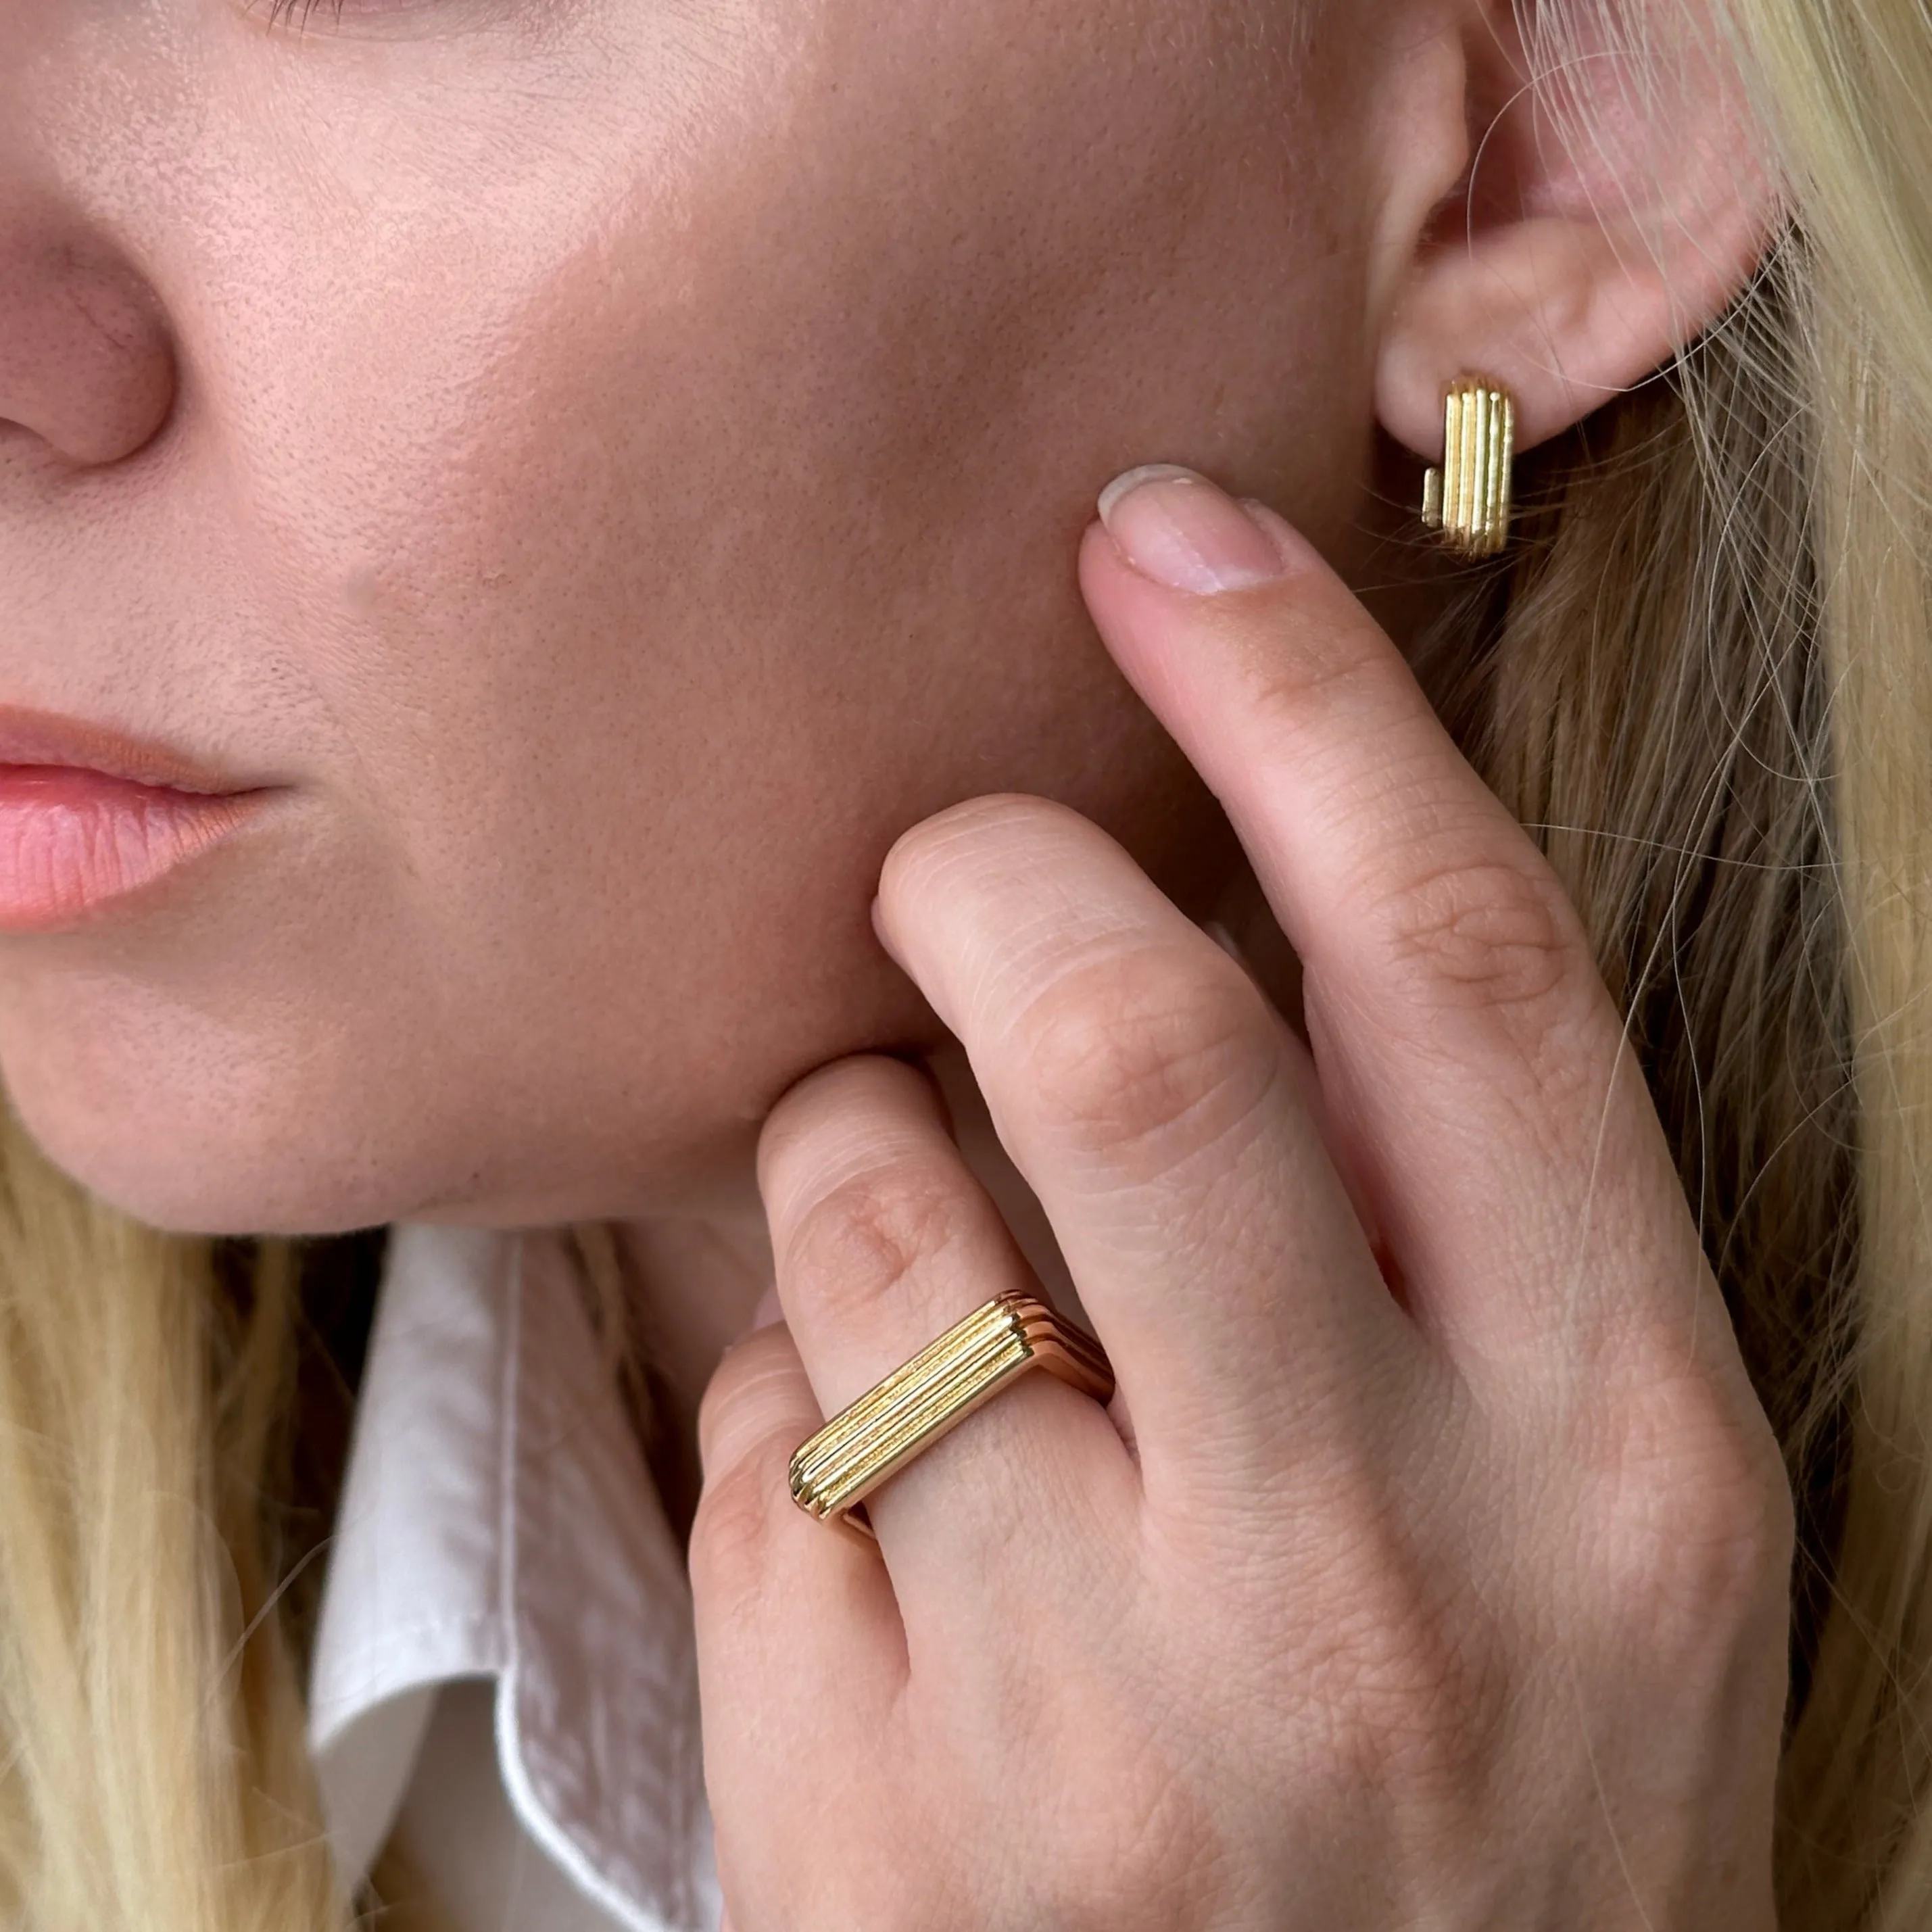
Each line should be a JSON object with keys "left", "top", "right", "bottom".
{"left": 1376, "top": 0, "right": 1777, "bottom": 462}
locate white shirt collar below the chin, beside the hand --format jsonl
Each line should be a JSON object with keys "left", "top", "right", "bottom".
{"left": 309, "top": 1225, "right": 719, "bottom": 1932}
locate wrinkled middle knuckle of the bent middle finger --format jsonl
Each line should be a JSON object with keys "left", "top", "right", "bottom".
{"left": 1020, "top": 948, "right": 1281, "bottom": 1171}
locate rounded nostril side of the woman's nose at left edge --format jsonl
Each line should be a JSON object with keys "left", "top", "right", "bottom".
{"left": 0, "top": 210, "right": 178, "bottom": 466}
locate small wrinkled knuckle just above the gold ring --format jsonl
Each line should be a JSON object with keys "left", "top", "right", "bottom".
{"left": 782, "top": 1157, "right": 972, "bottom": 1318}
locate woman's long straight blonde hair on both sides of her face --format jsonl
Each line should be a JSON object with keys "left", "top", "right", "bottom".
{"left": 0, "top": 0, "right": 1932, "bottom": 1932}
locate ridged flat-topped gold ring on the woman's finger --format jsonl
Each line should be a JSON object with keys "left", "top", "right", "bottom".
{"left": 792, "top": 1293, "right": 1113, "bottom": 1532}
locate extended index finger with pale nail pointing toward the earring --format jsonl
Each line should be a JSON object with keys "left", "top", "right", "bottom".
{"left": 1080, "top": 469, "right": 1706, "bottom": 1375}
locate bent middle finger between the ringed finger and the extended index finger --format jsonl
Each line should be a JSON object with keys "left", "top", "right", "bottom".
{"left": 879, "top": 798, "right": 1416, "bottom": 1501}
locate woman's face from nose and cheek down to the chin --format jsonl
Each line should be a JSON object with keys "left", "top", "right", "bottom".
{"left": 0, "top": 0, "right": 1405, "bottom": 1231}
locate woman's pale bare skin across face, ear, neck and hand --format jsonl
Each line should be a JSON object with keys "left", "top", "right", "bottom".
{"left": 0, "top": 0, "right": 1791, "bottom": 1932}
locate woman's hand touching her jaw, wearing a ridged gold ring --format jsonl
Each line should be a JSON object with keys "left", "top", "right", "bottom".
{"left": 692, "top": 477, "right": 1791, "bottom": 1932}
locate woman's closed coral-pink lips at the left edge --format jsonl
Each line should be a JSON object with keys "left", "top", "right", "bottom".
{"left": 0, "top": 705, "right": 266, "bottom": 933}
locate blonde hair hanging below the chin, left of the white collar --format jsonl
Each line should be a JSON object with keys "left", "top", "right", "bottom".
{"left": 0, "top": 1122, "right": 346, "bottom": 1932}
